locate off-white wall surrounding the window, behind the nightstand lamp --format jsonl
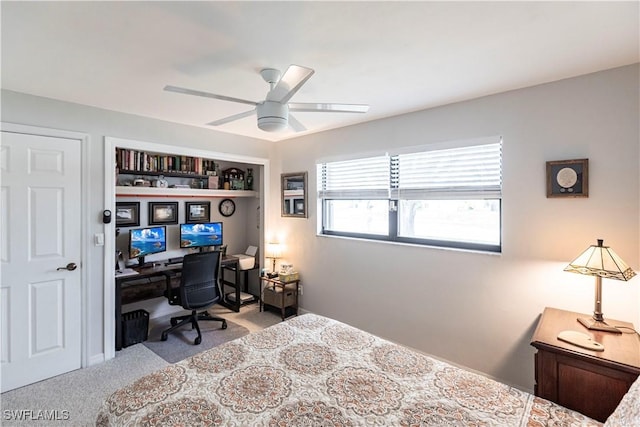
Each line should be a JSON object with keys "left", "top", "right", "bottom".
{"left": 267, "top": 64, "right": 640, "bottom": 390}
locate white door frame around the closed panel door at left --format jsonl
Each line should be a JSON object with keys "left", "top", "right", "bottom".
{"left": 0, "top": 122, "right": 91, "bottom": 368}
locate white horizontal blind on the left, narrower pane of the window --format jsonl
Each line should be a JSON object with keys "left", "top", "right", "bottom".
{"left": 317, "top": 155, "right": 391, "bottom": 200}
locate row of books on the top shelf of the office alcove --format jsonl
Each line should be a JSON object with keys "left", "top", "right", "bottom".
{"left": 116, "top": 148, "right": 217, "bottom": 175}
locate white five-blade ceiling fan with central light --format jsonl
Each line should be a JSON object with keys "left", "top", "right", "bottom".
{"left": 164, "top": 65, "right": 369, "bottom": 132}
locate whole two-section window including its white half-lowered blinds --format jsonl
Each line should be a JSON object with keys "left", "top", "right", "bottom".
{"left": 317, "top": 138, "right": 502, "bottom": 252}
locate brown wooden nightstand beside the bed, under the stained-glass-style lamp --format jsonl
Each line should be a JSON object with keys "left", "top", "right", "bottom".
{"left": 531, "top": 307, "right": 640, "bottom": 422}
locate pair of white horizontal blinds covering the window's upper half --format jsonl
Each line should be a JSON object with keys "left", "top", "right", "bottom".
{"left": 317, "top": 141, "right": 502, "bottom": 200}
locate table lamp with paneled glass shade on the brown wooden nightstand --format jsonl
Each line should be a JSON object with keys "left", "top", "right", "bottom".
{"left": 564, "top": 239, "right": 636, "bottom": 334}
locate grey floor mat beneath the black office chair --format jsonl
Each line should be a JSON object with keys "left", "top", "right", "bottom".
{"left": 143, "top": 313, "right": 249, "bottom": 363}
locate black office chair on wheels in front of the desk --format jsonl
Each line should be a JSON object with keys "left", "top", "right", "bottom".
{"left": 161, "top": 251, "right": 227, "bottom": 345}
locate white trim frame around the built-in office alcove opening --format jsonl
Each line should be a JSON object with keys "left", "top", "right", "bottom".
{"left": 103, "top": 136, "right": 271, "bottom": 360}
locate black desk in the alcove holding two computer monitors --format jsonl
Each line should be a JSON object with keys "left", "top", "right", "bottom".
{"left": 115, "top": 256, "right": 240, "bottom": 351}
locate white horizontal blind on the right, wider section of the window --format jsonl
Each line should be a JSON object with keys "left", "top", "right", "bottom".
{"left": 392, "top": 142, "right": 502, "bottom": 200}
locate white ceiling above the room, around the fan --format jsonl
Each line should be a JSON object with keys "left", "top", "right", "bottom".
{"left": 1, "top": 1, "right": 640, "bottom": 141}
